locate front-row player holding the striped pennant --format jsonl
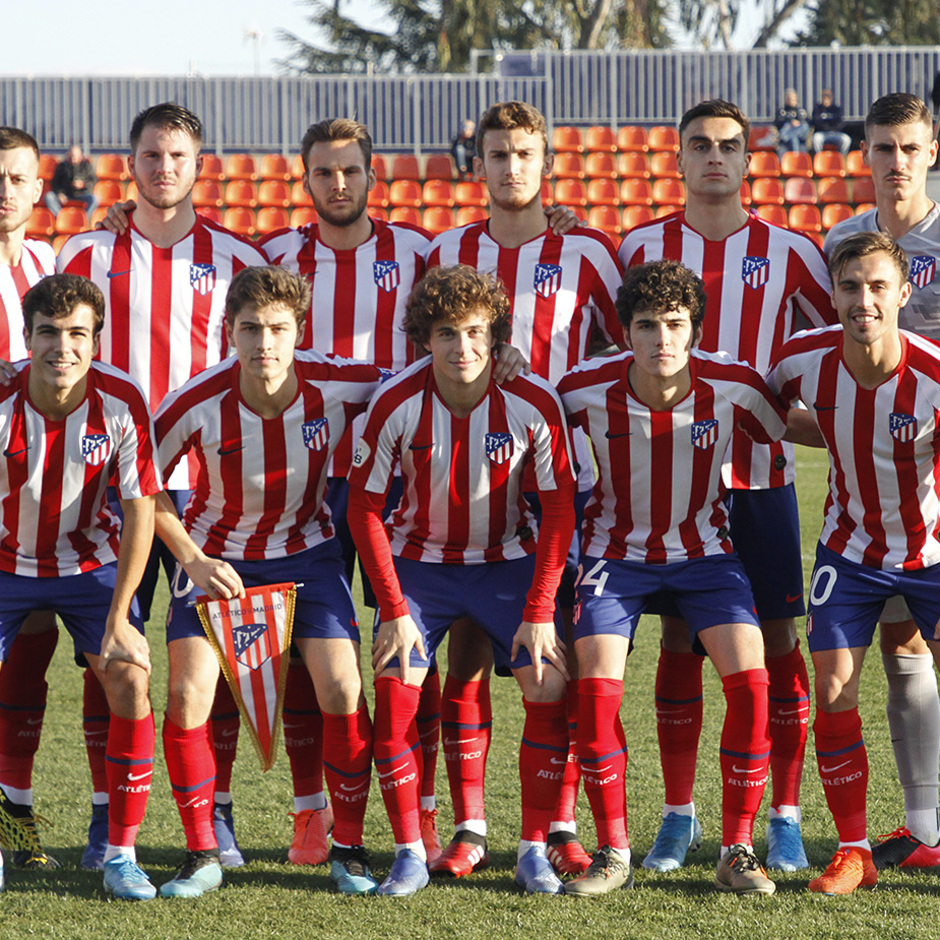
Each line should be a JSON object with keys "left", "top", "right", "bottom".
{"left": 157, "top": 268, "right": 380, "bottom": 897}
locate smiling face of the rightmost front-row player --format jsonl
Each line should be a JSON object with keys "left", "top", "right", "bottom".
{"left": 832, "top": 251, "right": 911, "bottom": 346}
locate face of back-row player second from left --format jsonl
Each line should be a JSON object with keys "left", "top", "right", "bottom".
{"left": 128, "top": 125, "right": 202, "bottom": 209}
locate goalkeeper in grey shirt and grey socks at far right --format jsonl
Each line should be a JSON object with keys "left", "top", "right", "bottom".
{"left": 825, "top": 92, "right": 940, "bottom": 868}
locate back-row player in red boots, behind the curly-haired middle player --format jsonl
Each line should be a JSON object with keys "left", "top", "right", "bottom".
{"left": 428, "top": 101, "right": 622, "bottom": 877}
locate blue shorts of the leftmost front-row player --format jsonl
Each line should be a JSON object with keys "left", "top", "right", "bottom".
{"left": 0, "top": 561, "right": 144, "bottom": 664}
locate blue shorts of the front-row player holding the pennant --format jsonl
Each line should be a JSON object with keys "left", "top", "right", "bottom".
{"left": 166, "top": 539, "right": 359, "bottom": 643}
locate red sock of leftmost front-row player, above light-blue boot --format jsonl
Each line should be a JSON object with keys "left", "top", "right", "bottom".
{"left": 106, "top": 712, "right": 156, "bottom": 846}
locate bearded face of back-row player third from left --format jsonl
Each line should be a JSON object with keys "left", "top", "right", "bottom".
{"left": 304, "top": 140, "right": 375, "bottom": 227}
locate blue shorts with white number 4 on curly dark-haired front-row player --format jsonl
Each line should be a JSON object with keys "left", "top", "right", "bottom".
{"left": 574, "top": 555, "right": 760, "bottom": 652}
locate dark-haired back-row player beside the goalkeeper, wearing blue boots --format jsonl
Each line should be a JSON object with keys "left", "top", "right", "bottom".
{"left": 620, "top": 100, "right": 832, "bottom": 871}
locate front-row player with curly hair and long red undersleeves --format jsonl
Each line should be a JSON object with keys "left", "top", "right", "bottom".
{"left": 349, "top": 265, "right": 575, "bottom": 895}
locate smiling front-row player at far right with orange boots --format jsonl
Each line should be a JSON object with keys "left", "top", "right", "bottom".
{"left": 768, "top": 232, "right": 940, "bottom": 894}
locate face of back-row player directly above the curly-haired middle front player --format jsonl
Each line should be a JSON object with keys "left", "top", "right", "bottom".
{"left": 473, "top": 127, "right": 551, "bottom": 210}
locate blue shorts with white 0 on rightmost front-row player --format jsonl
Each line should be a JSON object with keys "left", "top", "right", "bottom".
{"left": 806, "top": 545, "right": 940, "bottom": 652}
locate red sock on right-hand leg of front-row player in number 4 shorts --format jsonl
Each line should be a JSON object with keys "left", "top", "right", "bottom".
{"left": 720, "top": 669, "right": 770, "bottom": 846}
